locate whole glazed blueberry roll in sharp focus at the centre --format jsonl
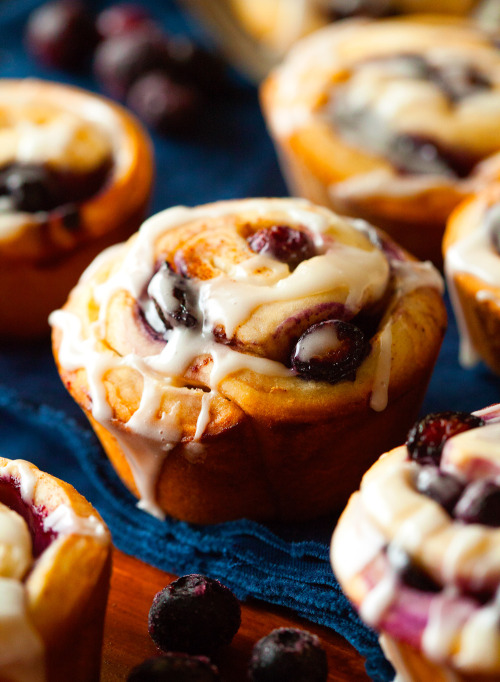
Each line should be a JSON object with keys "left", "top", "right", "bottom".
{"left": 51, "top": 199, "right": 445, "bottom": 523}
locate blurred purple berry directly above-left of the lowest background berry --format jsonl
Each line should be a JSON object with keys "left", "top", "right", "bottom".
{"left": 94, "top": 28, "right": 169, "bottom": 99}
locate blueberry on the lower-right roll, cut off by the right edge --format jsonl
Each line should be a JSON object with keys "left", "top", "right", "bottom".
{"left": 453, "top": 480, "right": 500, "bottom": 528}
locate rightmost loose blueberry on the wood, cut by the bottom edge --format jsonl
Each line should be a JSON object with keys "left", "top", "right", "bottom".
{"left": 248, "top": 628, "right": 328, "bottom": 682}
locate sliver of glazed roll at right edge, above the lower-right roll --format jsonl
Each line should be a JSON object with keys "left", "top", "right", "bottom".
{"left": 443, "top": 185, "right": 500, "bottom": 374}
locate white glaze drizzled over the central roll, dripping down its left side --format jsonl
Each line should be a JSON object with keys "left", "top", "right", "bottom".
{"left": 50, "top": 199, "right": 442, "bottom": 516}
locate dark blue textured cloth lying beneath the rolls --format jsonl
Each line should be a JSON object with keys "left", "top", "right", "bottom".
{"left": 0, "top": 0, "right": 500, "bottom": 682}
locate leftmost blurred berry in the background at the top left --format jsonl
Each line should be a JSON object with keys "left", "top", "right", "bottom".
{"left": 25, "top": 0, "right": 99, "bottom": 70}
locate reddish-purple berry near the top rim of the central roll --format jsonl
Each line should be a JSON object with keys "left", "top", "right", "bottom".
{"left": 247, "top": 225, "right": 316, "bottom": 270}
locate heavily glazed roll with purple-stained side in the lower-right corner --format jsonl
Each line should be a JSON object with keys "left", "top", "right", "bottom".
{"left": 331, "top": 405, "right": 500, "bottom": 682}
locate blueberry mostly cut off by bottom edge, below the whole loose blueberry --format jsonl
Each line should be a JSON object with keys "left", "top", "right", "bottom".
{"left": 127, "top": 653, "right": 219, "bottom": 682}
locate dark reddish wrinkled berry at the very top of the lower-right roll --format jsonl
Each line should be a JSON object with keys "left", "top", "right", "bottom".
{"left": 406, "top": 412, "right": 484, "bottom": 465}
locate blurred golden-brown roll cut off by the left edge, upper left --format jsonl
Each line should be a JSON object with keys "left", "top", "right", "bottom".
{"left": 0, "top": 80, "right": 152, "bottom": 337}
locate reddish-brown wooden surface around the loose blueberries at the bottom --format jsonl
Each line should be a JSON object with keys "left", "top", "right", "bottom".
{"left": 101, "top": 550, "right": 370, "bottom": 682}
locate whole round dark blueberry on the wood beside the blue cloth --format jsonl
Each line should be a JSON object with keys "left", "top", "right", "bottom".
{"left": 148, "top": 574, "right": 241, "bottom": 654}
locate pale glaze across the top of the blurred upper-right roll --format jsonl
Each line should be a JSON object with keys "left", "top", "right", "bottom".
{"left": 267, "top": 20, "right": 500, "bottom": 201}
